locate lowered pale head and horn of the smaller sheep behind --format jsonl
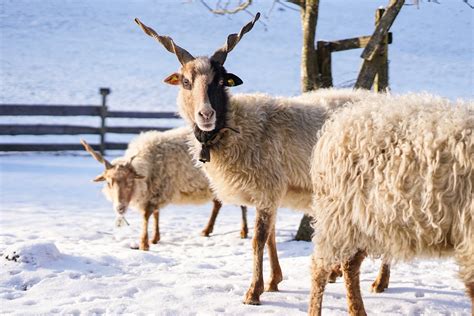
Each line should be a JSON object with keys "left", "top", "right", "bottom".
{"left": 81, "top": 139, "right": 145, "bottom": 215}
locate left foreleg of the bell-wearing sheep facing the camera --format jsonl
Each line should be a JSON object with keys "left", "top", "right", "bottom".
{"left": 244, "top": 208, "right": 276, "bottom": 305}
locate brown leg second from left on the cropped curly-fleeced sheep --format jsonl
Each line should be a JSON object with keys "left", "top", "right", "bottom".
{"left": 342, "top": 250, "right": 367, "bottom": 315}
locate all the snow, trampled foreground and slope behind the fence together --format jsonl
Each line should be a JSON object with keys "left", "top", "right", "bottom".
{"left": 0, "top": 0, "right": 474, "bottom": 315}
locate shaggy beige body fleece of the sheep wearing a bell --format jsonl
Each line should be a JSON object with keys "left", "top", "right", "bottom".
{"left": 185, "top": 90, "right": 371, "bottom": 211}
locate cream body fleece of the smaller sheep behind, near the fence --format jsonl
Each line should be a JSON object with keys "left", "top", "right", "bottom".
{"left": 104, "top": 128, "right": 213, "bottom": 209}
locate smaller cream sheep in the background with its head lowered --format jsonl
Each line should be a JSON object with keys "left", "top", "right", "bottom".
{"left": 81, "top": 128, "right": 248, "bottom": 250}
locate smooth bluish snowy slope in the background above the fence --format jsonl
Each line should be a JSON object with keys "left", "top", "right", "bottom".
{"left": 0, "top": 0, "right": 474, "bottom": 111}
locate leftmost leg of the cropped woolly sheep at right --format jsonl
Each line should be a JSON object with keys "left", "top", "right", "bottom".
{"left": 308, "top": 254, "right": 329, "bottom": 316}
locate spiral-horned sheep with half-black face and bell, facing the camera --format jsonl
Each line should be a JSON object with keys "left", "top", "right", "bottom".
{"left": 135, "top": 14, "right": 388, "bottom": 305}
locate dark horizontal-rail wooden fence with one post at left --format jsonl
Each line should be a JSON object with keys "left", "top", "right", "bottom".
{"left": 0, "top": 88, "right": 179, "bottom": 154}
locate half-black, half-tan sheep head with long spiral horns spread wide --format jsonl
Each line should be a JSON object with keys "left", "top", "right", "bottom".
{"left": 135, "top": 13, "right": 260, "bottom": 132}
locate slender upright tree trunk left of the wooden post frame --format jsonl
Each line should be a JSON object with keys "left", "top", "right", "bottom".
{"left": 301, "top": 0, "right": 320, "bottom": 92}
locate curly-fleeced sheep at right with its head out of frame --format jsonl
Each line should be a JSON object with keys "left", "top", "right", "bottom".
{"left": 309, "top": 94, "right": 474, "bottom": 315}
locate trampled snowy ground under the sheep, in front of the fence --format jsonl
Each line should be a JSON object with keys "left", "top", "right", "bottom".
{"left": 0, "top": 155, "right": 471, "bottom": 316}
